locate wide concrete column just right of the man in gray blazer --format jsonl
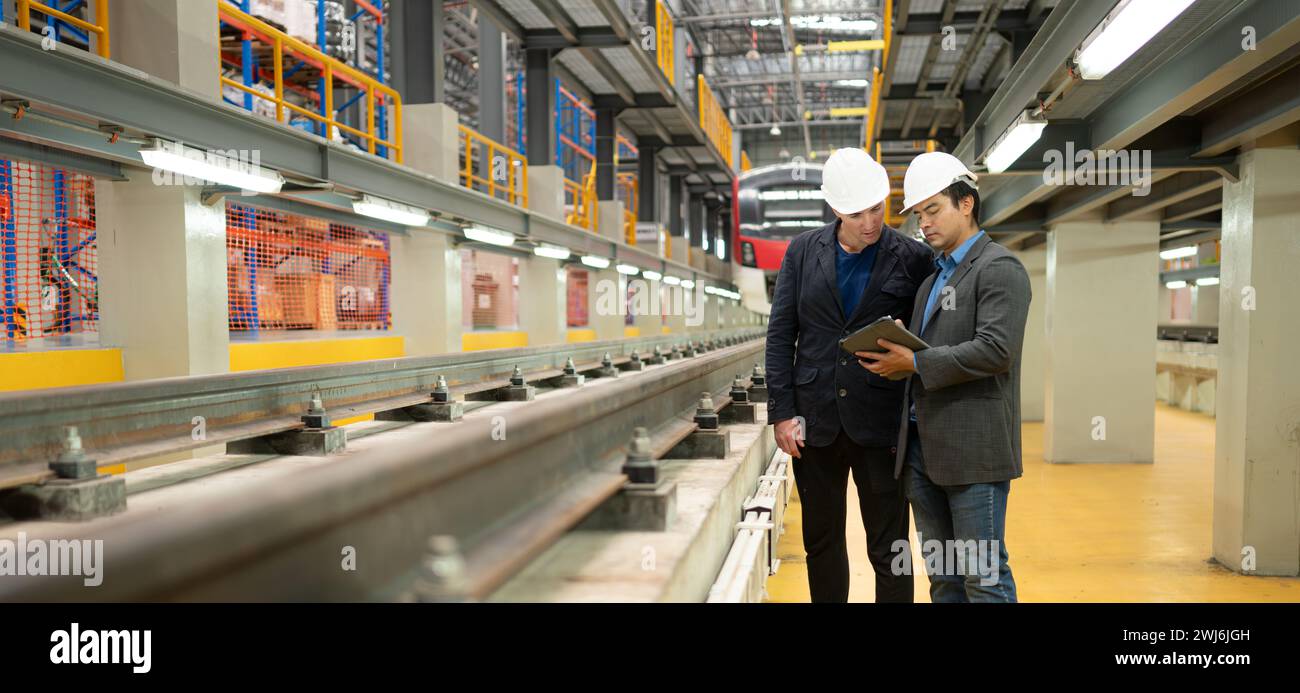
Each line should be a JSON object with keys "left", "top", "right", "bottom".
{"left": 1043, "top": 220, "right": 1160, "bottom": 463}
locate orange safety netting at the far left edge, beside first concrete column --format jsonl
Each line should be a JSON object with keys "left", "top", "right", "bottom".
{"left": 0, "top": 159, "right": 99, "bottom": 345}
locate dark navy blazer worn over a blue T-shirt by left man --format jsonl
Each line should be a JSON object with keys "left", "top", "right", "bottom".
{"left": 767, "top": 220, "right": 936, "bottom": 447}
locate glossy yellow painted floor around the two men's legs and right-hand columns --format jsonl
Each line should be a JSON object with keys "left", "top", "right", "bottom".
{"left": 767, "top": 404, "right": 1300, "bottom": 602}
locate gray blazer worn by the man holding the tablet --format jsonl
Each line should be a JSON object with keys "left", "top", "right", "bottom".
{"left": 894, "top": 234, "right": 1030, "bottom": 486}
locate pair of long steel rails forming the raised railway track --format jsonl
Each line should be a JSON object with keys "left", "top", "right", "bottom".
{"left": 0, "top": 328, "right": 763, "bottom": 601}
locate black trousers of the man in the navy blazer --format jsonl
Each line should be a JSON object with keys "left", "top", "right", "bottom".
{"left": 793, "top": 430, "right": 913, "bottom": 603}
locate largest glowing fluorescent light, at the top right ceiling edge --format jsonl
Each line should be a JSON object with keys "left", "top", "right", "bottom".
{"left": 1075, "top": 0, "right": 1193, "bottom": 79}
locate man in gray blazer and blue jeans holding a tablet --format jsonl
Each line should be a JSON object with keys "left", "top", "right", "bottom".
{"left": 857, "top": 152, "right": 1030, "bottom": 602}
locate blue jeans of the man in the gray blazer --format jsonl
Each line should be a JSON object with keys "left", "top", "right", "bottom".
{"left": 902, "top": 423, "right": 1015, "bottom": 603}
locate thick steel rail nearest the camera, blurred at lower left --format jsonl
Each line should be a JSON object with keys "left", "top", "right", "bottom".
{"left": 0, "top": 339, "right": 763, "bottom": 601}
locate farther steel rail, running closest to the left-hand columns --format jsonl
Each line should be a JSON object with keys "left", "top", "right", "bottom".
{"left": 0, "top": 328, "right": 762, "bottom": 489}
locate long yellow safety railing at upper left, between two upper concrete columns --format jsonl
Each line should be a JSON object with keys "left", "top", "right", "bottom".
{"left": 216, "top": 0, "right": 402, "bottom": 164}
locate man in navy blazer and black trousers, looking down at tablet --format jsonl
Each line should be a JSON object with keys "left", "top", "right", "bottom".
{"left": 767, "top": 148, "right": 933, "bottom": 602}
